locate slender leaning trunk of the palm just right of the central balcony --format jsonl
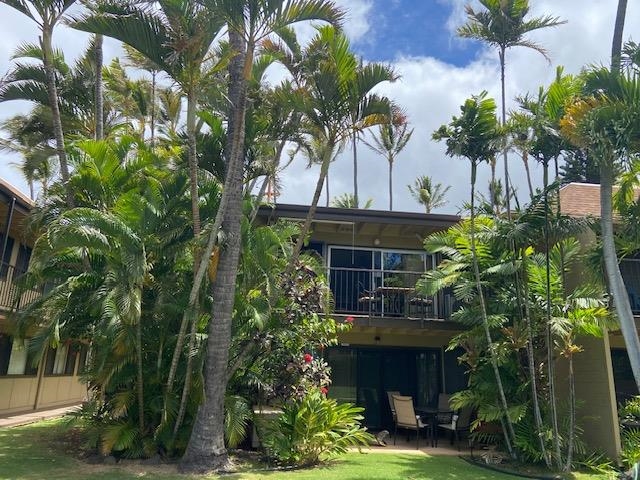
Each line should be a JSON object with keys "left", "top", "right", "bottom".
{"left": 470, "top": 161, "right": 516, "bottom": 458}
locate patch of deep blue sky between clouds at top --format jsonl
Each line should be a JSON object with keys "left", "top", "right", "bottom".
{"left": 354, "top": 0, "right": 480, "bottom": 67}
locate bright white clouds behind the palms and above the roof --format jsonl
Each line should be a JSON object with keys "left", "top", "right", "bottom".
{"left": 0, "top": 0, "right": 640, "bottom": 212}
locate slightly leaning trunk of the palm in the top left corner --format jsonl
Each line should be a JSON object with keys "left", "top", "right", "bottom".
{"left": 40, "top": 25, "right": 75, "bottom": 207}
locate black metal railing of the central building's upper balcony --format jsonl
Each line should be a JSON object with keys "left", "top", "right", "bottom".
{"left": 329, "top": 268, "right": 453, "bottom": 319}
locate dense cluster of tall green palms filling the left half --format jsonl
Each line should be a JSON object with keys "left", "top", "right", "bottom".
{"left": 0, "top": 0, "right": 410, "bottom": 472}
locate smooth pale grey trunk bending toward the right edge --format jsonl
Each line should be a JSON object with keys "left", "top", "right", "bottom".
{"left": 600, "top": 159, "right": 640, "bottom": 390}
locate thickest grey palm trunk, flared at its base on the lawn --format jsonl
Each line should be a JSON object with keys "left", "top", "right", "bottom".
{"left": 180, "top": 29, "right": 253, "bottom": 473}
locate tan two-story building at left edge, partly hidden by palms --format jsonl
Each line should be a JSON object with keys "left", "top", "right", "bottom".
{"left": 0, "top": 178, "right": 87, "bottom": 416}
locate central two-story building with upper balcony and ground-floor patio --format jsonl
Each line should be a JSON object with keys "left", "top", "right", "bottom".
{"left": 260, "top": 204, "right": 466, "bottom": 429}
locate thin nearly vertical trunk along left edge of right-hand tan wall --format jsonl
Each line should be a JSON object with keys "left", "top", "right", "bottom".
{"left": 542, "top": 159, "right": 562, "bottom": 466}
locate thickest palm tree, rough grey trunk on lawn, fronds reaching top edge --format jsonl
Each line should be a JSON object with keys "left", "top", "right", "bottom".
{"left": 180, "top": 0, "right": 343, "bottom": 472}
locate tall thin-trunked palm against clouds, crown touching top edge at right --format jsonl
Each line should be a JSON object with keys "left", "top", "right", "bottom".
{"left": 458, "top": 0, "right": 566, "bottom": 218}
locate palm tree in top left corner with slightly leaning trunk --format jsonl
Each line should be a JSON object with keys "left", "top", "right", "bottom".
{"left": 0, "top": 0, "right": 76, "bottom": 201}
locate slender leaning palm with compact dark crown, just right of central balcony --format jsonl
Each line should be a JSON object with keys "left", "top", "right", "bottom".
{"left": 433, "top": 92, "right": 515, "bottom": 457}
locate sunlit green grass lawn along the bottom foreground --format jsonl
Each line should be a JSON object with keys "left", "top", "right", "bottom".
{"left": 0, "top": 420, "right": 606, "bottom": 480}
